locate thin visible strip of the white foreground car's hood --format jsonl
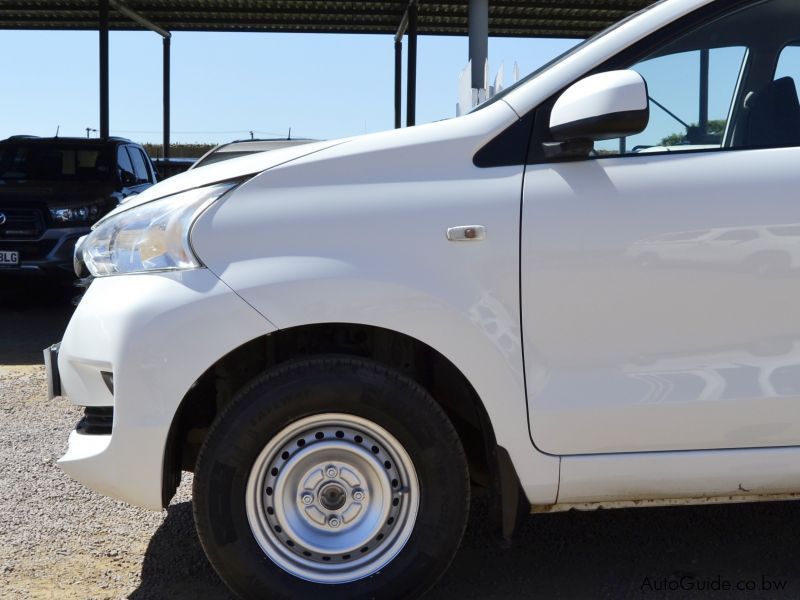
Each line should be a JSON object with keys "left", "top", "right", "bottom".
{"left": 106, "top": 138, "right": 351, "bottom": 218}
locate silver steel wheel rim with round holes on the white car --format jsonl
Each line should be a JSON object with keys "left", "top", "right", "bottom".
{"left": 245, "top": 413, "right": 420, "bottom": 584}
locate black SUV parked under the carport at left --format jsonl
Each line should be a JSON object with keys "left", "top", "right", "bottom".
{"left": 0, "top": 136, "right": 156, "bottom": 283}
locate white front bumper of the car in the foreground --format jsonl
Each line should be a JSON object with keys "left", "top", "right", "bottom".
{"left": 51, "top": 269, "right": 274, "bottom": 510}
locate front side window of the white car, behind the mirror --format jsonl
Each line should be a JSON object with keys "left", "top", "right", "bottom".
{"left": 584, "top": 0, "right": 800, "bottom": 158}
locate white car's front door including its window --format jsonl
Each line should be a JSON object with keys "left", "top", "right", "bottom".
{"left": 521, "top": 0, "right": 800, "bottom": 454}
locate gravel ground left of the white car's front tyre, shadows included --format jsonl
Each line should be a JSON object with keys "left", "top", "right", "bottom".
{"left": 0, "top": 290, "right": 231, "bottom": 600}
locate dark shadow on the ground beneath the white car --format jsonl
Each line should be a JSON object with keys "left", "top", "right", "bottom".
{"left": 130, "top": 494, "right": 800, "bottom": 600}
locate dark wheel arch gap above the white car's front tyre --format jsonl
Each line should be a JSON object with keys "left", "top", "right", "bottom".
{"left": 162, "top": 323, "right": 528, "bottom": 537}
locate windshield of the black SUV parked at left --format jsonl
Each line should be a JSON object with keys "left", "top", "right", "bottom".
{"left": 0, "top": 143, "right": 111, "bottom": 181}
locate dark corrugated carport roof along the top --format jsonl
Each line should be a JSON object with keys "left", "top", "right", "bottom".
{"left": 0, "top": 0, "right": 654, "bottom": 38}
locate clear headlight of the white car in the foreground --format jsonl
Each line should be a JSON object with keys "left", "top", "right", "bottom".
{"left": 81, "top": 183, "right": 236, "bottom": 277}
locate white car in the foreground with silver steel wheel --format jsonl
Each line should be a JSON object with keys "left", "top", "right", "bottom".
{"left": 46, "top": 0, "right": 800, "bottom": 598}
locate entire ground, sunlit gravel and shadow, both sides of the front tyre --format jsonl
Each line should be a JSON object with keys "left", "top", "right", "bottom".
{"left": 0, "top": 294, "right": 800, "bottom": 600}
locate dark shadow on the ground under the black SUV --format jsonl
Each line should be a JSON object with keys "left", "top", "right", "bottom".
{"left": 0, "top": 284, "right": 75, "bottom": 365}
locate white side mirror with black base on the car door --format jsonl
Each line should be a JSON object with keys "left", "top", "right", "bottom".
{"left": 544, "top": 71, "right": 650, "bottom": 158}
